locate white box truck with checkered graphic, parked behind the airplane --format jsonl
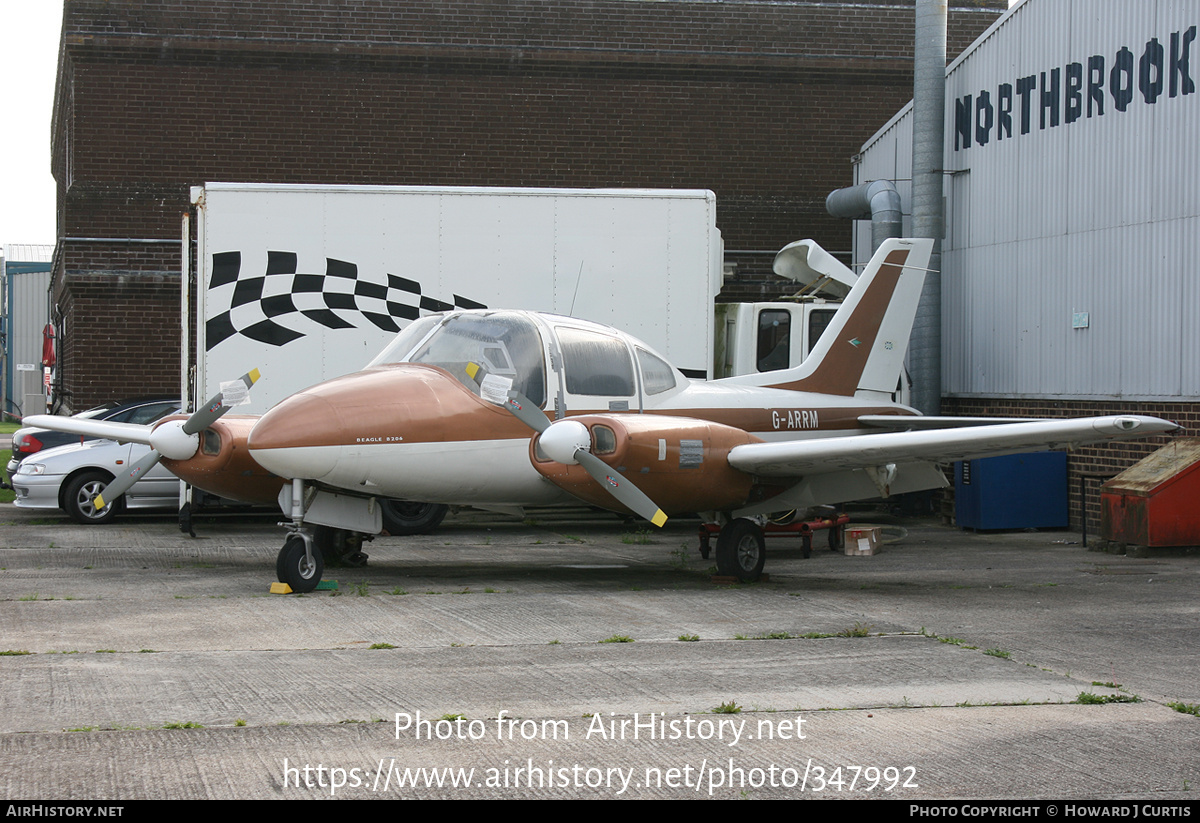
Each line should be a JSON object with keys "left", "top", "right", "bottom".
{"left": 181, "top": 182, "right": 854, "bottom": 533}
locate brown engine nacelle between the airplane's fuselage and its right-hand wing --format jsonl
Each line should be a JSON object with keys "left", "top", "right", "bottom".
{"left": 529, "top": 414, "right": 761, "bottom": 515}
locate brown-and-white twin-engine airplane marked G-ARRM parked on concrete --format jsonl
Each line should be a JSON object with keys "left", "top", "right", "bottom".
{"left": 30, "top": 240, "right": 1178, "bottom": 591}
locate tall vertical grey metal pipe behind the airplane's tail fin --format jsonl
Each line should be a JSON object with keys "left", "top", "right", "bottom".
{"left": 908, "top": 0, "right": 947, "bottom": 415}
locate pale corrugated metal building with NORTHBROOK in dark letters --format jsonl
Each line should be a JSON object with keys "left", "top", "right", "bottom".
{"left": 854, "top": 0, "right": 1200, "bottom": 527}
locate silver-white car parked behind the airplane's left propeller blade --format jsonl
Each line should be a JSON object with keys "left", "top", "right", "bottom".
{"left": 12, "top": 440, "right": 179, "bottom": 524}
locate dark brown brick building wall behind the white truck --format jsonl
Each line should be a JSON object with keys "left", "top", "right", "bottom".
{"left": 53, "top": 0, "right": 1006, "bottom": 406}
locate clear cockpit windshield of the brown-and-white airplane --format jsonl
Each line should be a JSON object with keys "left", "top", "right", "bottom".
{"left": 371, "top": 312, "right": 546, "bottom": 406}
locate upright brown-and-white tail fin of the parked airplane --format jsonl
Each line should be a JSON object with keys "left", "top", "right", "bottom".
{"left": 728, "top": 239, "right": 934, "bottom": 397}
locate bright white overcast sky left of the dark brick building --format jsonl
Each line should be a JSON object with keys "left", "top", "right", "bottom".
{"left": 0, "top": 0, "right": 1012, "bottom": 254}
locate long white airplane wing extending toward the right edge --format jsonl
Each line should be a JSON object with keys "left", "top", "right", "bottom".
{"left": 728, "top": 415, "right": 1180, "bottom": 477}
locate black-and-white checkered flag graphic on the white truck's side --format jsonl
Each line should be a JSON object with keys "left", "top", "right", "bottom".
{"left": 205, "top": 252, "right": 486, "bottom": 350}
